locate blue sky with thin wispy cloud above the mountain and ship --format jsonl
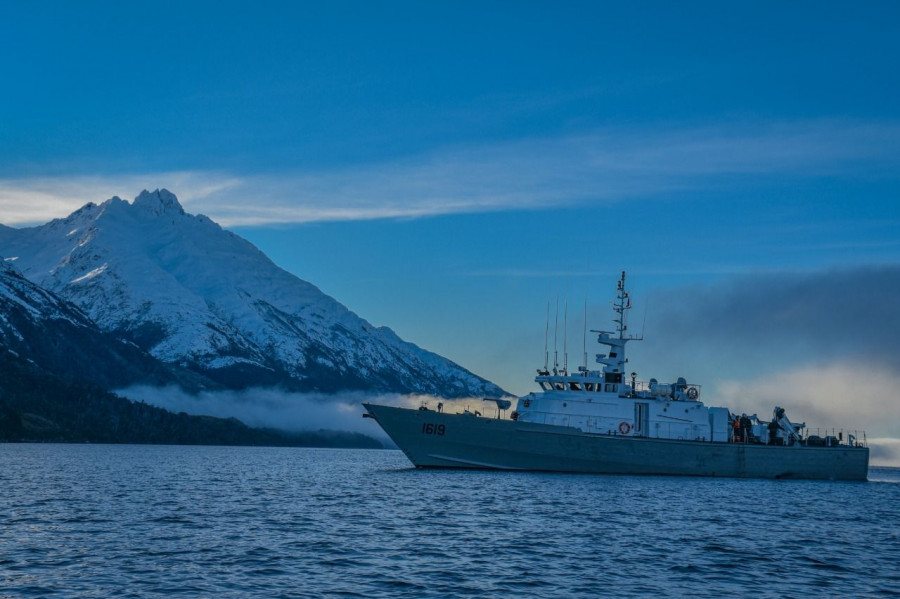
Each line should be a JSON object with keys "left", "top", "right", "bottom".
{"left": 0, "top": 2, "right": 900, "bottom": 458}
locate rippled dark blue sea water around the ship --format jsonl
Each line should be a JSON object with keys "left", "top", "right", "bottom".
{"left": 0, "top": 445, "right": 900, "bottom": 598}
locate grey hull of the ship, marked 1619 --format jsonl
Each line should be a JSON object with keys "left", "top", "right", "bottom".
{"left": 363, "top": 404, "right": 869, "bottom": 480}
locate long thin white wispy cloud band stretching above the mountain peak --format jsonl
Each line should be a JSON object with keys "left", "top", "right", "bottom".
{"left": 0, "top": 120, "right": 900, "bottom": 226}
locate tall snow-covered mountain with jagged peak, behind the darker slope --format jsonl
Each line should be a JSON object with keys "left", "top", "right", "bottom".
{"left": 0, "top": 190, "right": 503, "bottom": 397}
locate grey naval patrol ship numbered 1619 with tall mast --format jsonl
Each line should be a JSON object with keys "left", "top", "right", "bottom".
{"left": 363, "top": 271, "right": 869, "bottom": 480}
